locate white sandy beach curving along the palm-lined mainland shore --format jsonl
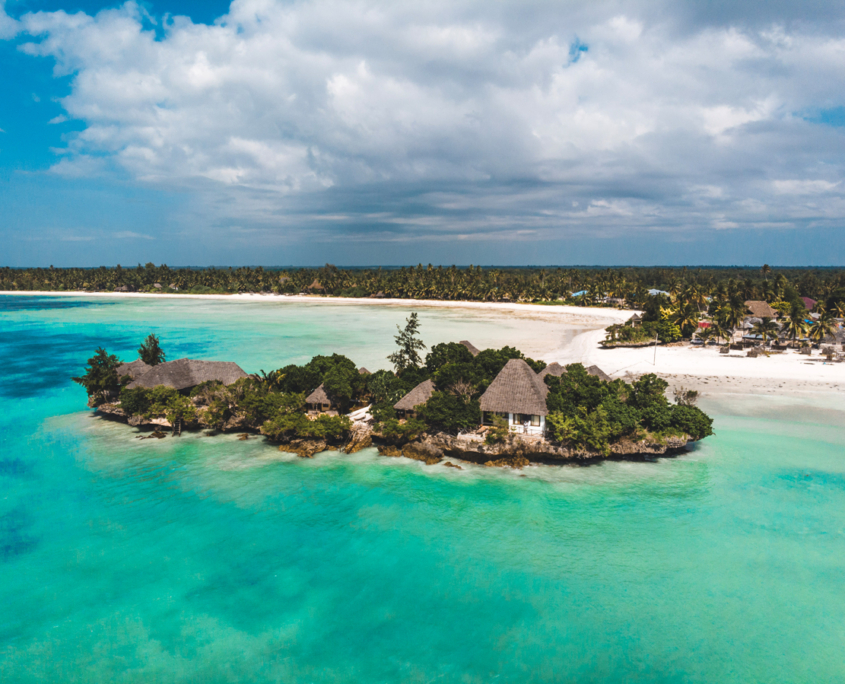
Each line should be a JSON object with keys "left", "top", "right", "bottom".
{"left": 0, "top": 291, "right": 845, "bottom": 394}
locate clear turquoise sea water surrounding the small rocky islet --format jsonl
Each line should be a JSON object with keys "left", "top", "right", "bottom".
{"left": 0, "top": 297, "right": 845, "bottom": 683}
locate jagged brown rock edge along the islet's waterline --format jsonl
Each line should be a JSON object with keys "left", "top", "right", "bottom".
{"left": 96, "top": 404, "right": 695, "bottom": 468}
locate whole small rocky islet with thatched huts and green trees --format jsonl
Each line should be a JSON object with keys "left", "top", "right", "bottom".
{"left": 74, "top": 314, "right": 713, "bottom": 468}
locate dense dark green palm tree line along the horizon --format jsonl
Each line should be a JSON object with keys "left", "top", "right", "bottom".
{"left": 6, "top": 263, "right": 845, "bottom": 308}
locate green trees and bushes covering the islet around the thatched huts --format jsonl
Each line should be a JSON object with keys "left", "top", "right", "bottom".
{"left": 74, "top": 314, "right": 712, "bottom": 455}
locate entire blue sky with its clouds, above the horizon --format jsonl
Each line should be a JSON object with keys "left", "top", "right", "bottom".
{"left": 0, "top": 0, "right": 845, "bottom": 266}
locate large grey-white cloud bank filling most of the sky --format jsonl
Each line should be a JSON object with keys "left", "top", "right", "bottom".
{"left": 8, "top": 0, "right": 845, "bottom": 248}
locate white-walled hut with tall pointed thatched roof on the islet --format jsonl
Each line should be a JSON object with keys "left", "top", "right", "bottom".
{"left": 481, "top": 359, "right": 549, "bottom": 435}
